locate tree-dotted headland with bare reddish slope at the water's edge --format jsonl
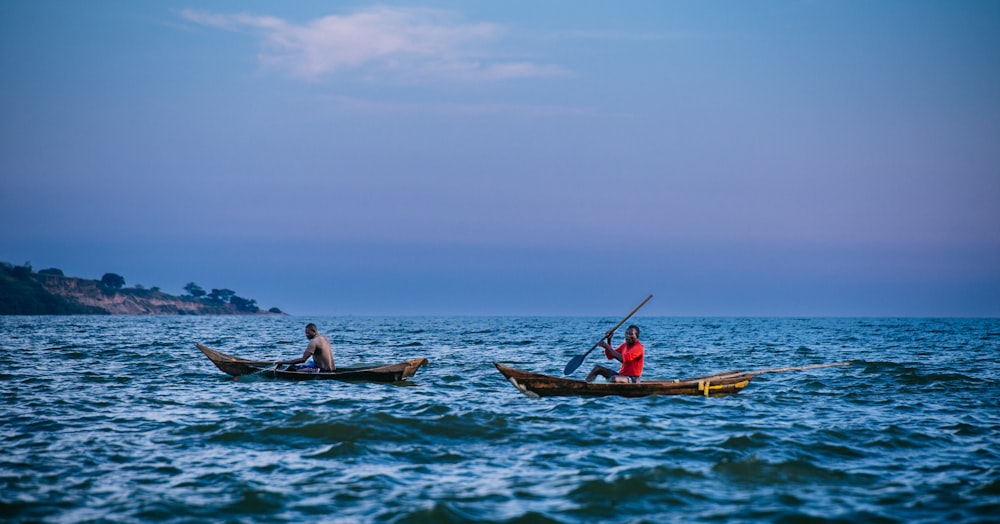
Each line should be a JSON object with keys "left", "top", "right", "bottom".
{"left": 0, "top": 262, "right": 284, "bottom": 315}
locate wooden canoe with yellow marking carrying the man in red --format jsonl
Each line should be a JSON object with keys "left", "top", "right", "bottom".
{"left": 493, "top": 362, "right": 754, "bottom": 397}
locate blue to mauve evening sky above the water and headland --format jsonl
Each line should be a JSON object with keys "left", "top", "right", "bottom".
{"left": 0, "top": 0, "right": 1000, "bottom": 317}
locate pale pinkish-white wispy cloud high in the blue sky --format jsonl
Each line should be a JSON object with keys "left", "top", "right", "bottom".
{"left": 181, "top": 7, "right": 569, "bottom": 82}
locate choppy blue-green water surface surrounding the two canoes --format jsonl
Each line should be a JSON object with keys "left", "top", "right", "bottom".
{"left": 0, "top": 315, "right": 1000, "bottom": 523}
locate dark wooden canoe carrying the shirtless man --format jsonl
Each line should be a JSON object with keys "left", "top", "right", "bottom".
{"left": 195, "top": 344, "right": 427, "bottom": 382}
